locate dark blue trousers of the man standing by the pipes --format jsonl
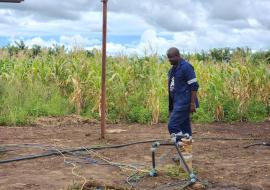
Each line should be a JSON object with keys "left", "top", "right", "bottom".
{"left": 168, "top": 110, "right": 192, "bottom": 136}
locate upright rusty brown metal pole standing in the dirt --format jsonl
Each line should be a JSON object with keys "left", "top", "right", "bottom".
{"left": 100, "top": 0, "right": 108, "bottom": 139}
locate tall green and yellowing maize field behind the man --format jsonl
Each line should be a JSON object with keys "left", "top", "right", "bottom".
{"left": 0, "top": 42, "right": 270, "bottom": 125}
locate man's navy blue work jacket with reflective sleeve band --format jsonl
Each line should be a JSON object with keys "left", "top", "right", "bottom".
{"left": 168, "top": 58, "right": 199, "bottom": 112}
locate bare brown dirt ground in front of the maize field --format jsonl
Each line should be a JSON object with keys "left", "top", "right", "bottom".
{"left": 0, "top": 116, "right": 270, "bottom": 190}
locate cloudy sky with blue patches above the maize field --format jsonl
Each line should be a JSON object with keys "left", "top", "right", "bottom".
{"left": 0, "top": 0, "right": 270, "bottom": 54}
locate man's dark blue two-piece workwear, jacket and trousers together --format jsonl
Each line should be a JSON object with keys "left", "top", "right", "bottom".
{"left": 168, "top": 58, "right": 199, "bottom": 136}
